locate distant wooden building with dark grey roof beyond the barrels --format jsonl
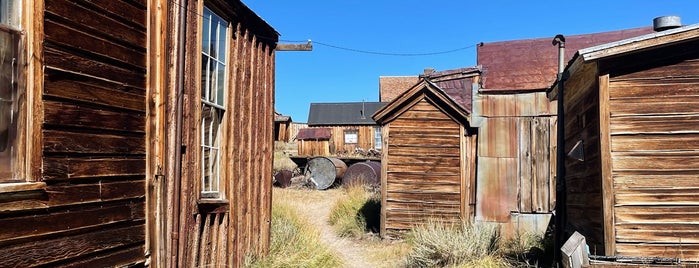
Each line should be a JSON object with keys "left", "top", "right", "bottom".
{"left": 297, "top": 102, "right": 385, "bottom": 156}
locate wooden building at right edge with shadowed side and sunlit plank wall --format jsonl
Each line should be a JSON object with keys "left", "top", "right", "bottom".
{"left": 549, "top": 24, "right": 699, "bottom": 261}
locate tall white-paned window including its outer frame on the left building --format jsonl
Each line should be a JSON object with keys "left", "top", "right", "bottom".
{"left": 197, "top": 5, "right": 232, "bottom": 199}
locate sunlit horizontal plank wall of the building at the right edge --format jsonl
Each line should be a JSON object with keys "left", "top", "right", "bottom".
{"left": 607, "top": 51, "right": 699, "bottom": 261}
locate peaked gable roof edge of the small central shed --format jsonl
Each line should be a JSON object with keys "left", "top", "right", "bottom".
{"left": 372, "top": 77, "right": 469, "bottom": 125}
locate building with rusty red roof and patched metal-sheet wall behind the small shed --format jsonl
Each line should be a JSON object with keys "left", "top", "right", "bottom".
{"left": 470, "top": 27, "right": 652, "bottom": 234}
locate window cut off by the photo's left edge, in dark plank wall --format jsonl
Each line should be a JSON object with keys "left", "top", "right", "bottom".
{"left": 0, "top": 0, "right": 21, "bottom": 182}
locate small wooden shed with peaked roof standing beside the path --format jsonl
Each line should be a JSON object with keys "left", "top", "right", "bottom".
{"left": 373, "top": 78, "right": 477, "bottom": 237}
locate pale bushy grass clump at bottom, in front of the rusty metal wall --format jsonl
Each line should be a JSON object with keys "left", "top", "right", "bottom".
{"left": 406, "top": 220, "right": 507, "bottom": 267}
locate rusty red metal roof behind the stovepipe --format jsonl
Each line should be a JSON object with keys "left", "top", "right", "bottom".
{"left": 477, "top": 27, "right": 653, "bottom": 91}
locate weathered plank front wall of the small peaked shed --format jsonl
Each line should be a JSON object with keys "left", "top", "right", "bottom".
{"left": 382, "top": 99, "right": 468, "bottom": 237}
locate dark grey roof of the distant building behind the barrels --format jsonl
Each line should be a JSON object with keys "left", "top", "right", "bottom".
{"left": 308, "top": 102, "right": 386, "bottom": 126}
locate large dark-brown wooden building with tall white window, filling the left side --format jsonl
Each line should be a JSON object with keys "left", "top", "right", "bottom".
{"left": 0, "top": 0, "right": 278, "bottom": 267}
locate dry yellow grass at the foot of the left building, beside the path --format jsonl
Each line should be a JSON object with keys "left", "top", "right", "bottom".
{"left": 246, "top": 199, "right": 342, "bottom": 268}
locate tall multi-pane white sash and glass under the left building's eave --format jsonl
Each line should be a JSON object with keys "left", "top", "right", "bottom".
{"left": 201, "top": 7, "right": 228, "bottom": 198}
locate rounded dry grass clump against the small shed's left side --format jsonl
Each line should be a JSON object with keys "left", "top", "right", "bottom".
{"left": 329, "top": 185, "right": 381, "bottom": 238}
